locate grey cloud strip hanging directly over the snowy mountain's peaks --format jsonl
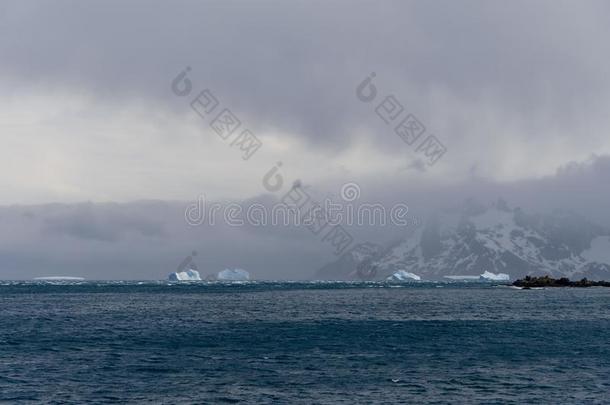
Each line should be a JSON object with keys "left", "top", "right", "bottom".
{"left": 362, "top": 155, "right": 610, "bottom": 227}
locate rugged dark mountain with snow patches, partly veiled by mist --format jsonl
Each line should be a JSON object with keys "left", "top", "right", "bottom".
{"left": 316, "top": 200, "right": 610, "bottom": 280}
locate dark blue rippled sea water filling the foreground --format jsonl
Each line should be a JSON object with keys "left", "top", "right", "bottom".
{"left": 0, "top": 282, "right": 610, "bottom": 404}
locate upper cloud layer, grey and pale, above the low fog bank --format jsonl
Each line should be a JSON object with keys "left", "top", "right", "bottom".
{"left": 0, "top": 1, "right": 610, "bottom": 203}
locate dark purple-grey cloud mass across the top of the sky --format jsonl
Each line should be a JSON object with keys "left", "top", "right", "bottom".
{"left": 0, "top": 1, "right": 610, "bottom": 152}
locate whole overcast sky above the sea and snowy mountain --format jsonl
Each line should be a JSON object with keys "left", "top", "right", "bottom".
{"left": 0, "top": 0, "right": 610, "bottom": 278}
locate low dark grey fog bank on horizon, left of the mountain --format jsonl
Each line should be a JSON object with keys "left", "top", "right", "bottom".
{"left": 0, "top": 198, "right": 333, "bottom": 280}
